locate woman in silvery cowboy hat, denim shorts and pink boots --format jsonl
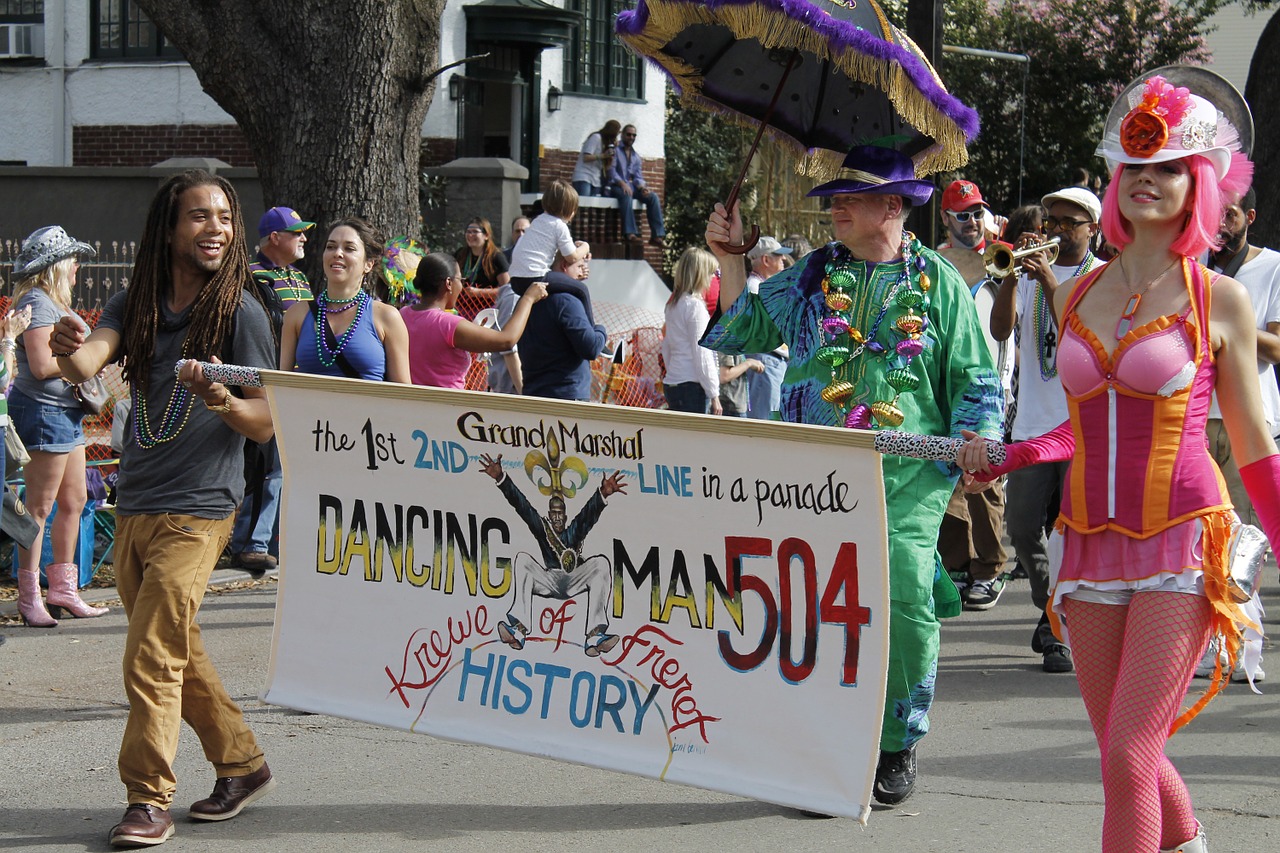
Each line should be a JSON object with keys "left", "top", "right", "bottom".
{"left": 9, "top": 225, "right": 108, "bottom": 628}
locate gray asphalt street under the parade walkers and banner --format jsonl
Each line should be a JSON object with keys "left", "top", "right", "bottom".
{"left": 0, "top": 566, "right": 1280, "bottom": 853}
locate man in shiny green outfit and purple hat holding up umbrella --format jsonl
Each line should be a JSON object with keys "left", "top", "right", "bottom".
{"left": 701, "top": 146, "right": 1004, "bottom": 804}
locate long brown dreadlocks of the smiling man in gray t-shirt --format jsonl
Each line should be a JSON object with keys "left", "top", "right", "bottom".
{"left": 120, "top": 169, "right": 257, "bottom": 392}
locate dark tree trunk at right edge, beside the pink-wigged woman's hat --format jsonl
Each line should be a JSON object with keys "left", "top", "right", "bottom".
{"left": 1244, "top": 13, "right": 1280, "bottom": 248}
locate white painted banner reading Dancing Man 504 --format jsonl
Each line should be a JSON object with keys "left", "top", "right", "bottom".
{"left": 262, "top": 371, "right": 888, "bottom": 821}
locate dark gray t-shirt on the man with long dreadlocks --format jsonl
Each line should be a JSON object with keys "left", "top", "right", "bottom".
{"left": 99, "top": 285, "right": 275, "bottom": 519}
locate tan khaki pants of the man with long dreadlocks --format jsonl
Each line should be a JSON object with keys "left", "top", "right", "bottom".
{"left": 115, "top": 515, "right": 262, "bottom": 808}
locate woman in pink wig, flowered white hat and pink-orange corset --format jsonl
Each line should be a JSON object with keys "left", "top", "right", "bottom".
{"left": 957, "top": 69, "right": 1280, "bottom": 853}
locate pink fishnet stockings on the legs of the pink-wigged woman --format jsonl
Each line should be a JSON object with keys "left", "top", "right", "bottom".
{"left": 1064, "top": 592, "right": 1210, "bottom": 853}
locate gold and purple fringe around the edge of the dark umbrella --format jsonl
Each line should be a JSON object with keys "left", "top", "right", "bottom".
{"left": 621, "top": 0, "right": 969, "bottom": 181}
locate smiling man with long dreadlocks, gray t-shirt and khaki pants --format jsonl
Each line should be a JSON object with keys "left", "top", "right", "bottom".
{"left": 50, "top": 172, "right": 275, "bottom": 847}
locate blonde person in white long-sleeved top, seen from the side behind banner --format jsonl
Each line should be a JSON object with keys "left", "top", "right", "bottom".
{"left": 662, "top": 247, "right": 723, "bottom": 415}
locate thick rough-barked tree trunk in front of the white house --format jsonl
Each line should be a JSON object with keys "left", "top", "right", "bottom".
{"left": 137, "top": 0, "right": 444, "bottom": 248}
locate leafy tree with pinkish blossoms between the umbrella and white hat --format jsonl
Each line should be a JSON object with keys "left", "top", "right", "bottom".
{"left": 941, "top": 0, "right": 1221, "bottom": 210}
